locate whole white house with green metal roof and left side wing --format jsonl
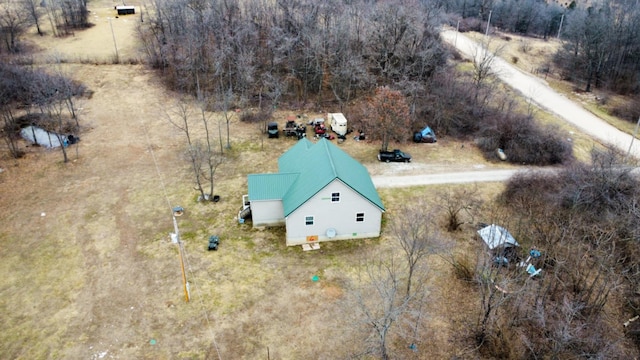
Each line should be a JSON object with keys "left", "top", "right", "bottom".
{"left": 248, "top": 138, "right": 384, "bottom": 245}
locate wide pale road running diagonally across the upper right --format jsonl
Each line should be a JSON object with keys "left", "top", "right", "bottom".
{"left": 441, "top": 30, "right": 640, "bottom": 158}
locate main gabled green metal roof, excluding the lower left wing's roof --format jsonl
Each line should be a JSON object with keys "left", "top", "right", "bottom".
{"left": 278, "top": 138, "right": 384, "bottom": 216}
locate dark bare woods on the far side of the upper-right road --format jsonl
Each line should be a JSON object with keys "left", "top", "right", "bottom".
{"left": 439, "top": 0, "right": 640, "bottom": 122}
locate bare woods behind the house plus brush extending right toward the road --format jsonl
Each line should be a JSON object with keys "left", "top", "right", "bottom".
{"left": 139, "top": 0, "right": 571, "bottom": 165}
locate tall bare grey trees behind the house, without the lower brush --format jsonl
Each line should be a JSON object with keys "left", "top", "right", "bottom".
{"left": 142, "top": 0, "right": 445, "bottom": 106}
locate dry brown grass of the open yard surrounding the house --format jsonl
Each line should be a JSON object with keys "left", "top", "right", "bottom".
{"left": 0, "top": 0, "right": 620, "bottom": 359}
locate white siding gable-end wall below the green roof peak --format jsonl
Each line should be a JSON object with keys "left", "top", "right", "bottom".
{"left": 284, "top": 180, "right": 382, "bottom": 246}
